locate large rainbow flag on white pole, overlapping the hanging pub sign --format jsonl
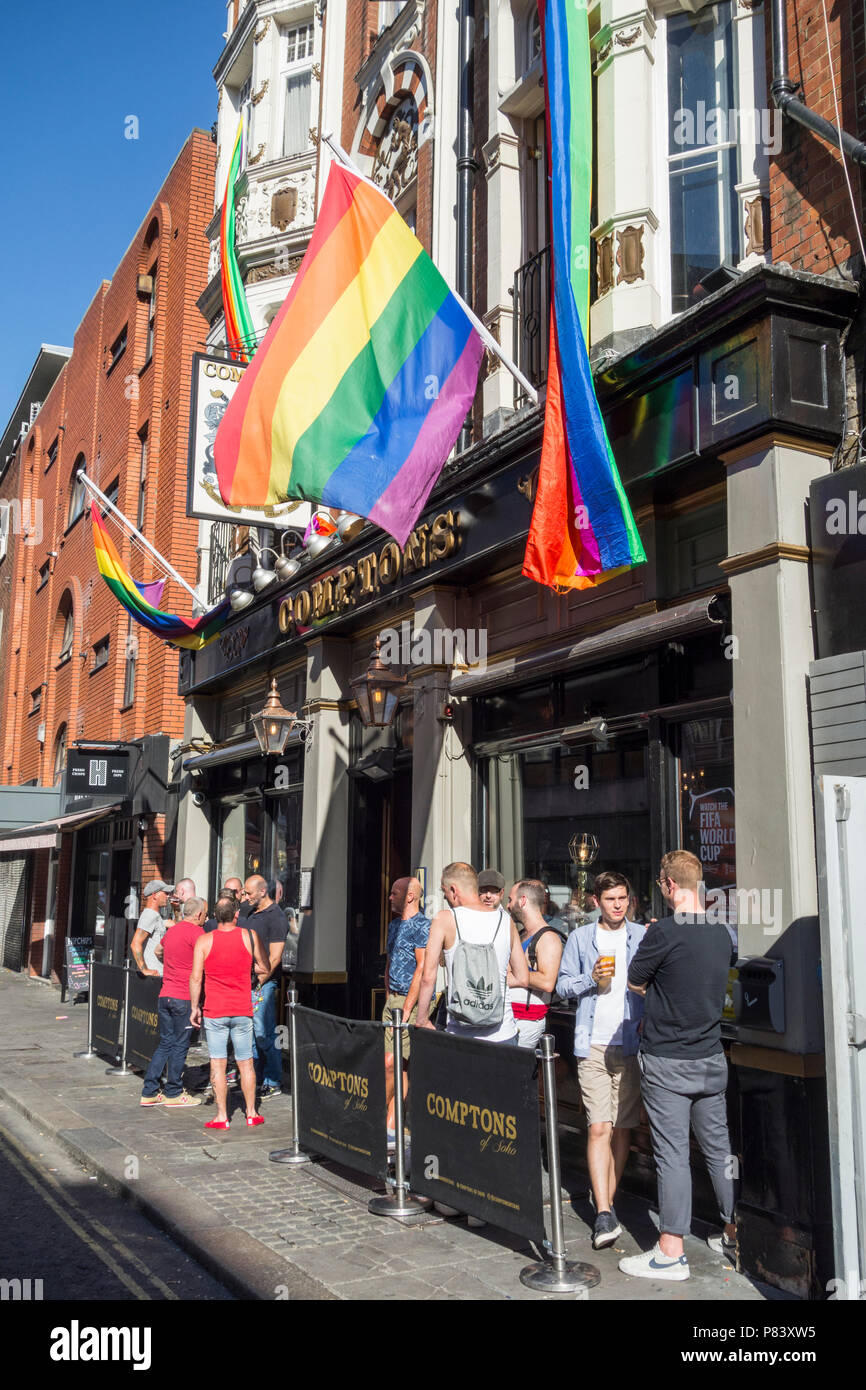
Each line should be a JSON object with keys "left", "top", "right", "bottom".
{"left": 214, "top": 163, "right": 482, "bottom": 545}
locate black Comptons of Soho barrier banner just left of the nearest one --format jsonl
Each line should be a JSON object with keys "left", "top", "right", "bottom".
{"left": 295, "top": 1005, "right": 388, "bottom": 1177}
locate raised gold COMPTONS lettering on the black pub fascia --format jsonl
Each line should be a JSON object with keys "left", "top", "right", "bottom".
{"left": 277, "top": 510, "right": 460, "bottom": 637}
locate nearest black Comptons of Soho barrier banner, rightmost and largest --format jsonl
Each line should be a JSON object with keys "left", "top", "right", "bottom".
{"left": 409, "top": 1029, "right": 545, "bottom": 1244}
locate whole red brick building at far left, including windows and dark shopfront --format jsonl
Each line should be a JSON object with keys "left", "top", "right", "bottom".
{"left": 0, "top": 131, "right": 214, "bottom": 974}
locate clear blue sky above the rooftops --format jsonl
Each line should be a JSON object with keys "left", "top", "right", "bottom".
{"left": 0, "top": 0, "right": 219, "bottom": 431}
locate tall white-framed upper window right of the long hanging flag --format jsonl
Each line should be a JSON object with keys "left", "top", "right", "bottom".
{"left": 667, "top": 3, "right": 741, "bottom": 314}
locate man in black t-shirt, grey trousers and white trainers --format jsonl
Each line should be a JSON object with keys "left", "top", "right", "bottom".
{"left": 620, "top": 849, "right": 737, "bottom": 1279}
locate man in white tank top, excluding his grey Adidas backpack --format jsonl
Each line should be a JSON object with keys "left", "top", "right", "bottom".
{"left": 417, "top": 862, "right": 530, "bottom": 1044}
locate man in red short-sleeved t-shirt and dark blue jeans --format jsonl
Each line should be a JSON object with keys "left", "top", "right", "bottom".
{"left": 140, "top": 897, "right": 207, "bottom": 1108}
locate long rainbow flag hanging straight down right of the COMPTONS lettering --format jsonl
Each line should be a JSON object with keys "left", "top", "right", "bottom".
{"left": 523, "top": 0, "right": 646, "bottom": 588}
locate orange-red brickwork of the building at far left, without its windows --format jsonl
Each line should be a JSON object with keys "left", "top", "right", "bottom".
{"left": 0, "top": 131, "right": 215, "bottom": 806}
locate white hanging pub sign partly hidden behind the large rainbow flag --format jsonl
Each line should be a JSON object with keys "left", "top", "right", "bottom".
{"left": 186, "top": 352, "right": 313, "bottom": 531}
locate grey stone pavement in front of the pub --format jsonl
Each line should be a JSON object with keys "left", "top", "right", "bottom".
{"left": 0, "top": 969, "right": 795, "bottom": 1302}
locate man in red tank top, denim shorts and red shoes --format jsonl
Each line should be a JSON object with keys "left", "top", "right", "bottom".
{"left": 189, "top": 898, "right": 270, "bottom": 1129}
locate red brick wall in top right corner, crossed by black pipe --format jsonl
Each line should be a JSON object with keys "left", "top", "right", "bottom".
{"left": 766, "top": 0, "right": 866, "bottom": 274}
